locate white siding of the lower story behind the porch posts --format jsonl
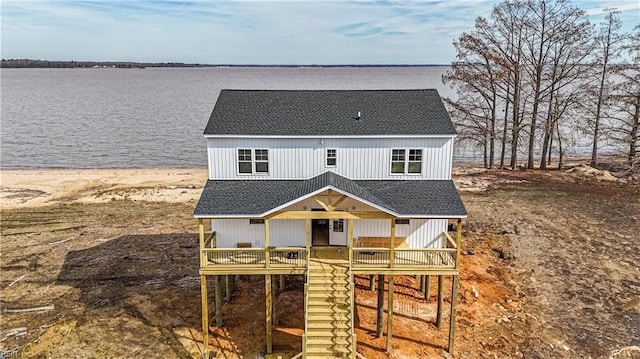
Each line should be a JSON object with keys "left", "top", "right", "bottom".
{"left": 212, "top": 219, "right": 448, "bottom": 248}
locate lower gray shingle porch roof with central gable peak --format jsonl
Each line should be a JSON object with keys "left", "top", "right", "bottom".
{"left": 194, "top": 172, "right": 467, "bottom": 218}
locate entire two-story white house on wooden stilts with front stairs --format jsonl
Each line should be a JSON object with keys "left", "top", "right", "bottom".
{"left": 194, "top": 89, "right": 467, "bottom": 358}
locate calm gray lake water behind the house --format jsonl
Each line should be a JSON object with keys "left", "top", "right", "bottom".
{"left": 0, "top": 66, "right": 454, "bottom": 168}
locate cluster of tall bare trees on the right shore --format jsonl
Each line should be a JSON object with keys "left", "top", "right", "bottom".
{"left": 443, "top": 0, "right": 640, "bottom": 169}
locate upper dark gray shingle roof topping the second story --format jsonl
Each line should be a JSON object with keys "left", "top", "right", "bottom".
{"left": 204, "top": 89, "right": 456, "bottom": 136}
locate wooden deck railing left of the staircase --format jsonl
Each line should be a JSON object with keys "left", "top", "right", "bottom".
{"left": 202, "top": 247, "right": 307, "bottom": 269}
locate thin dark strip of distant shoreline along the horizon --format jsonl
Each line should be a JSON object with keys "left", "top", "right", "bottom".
{"left": 0, "top": 59, "right": 450, "bottom": 69}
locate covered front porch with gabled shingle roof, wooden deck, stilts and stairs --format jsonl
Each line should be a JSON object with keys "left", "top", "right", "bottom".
{"left": 195, "top": 172, "right": 466, "bottom": 359}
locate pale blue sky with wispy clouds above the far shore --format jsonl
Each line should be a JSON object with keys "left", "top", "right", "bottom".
{"left": 0, "top": 0, "right": 640, "bottom": 65}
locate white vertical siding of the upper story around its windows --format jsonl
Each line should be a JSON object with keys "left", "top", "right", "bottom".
{"left": 207, "top": 137, "right": 453, "bottom": 180}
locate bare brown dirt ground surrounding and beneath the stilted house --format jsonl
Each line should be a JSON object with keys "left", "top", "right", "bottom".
{"left": 0, "top": 166, "right": 640, "bottom": 359}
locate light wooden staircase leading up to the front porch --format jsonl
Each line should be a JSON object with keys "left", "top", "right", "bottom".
{"left": 303, "top": 247, "right": 355, "bottom": 359}
